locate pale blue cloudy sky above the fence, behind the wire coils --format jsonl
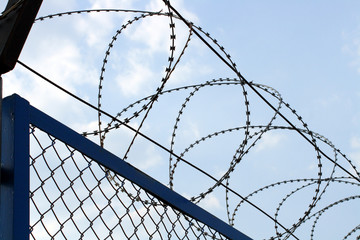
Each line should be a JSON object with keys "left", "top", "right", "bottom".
{"left": 0, "top": 0, "right": 360, "bottom": 239}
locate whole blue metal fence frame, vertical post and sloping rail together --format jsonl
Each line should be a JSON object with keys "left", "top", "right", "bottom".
{"left": 0, "top": 95, "right": 250, "bottom": 240}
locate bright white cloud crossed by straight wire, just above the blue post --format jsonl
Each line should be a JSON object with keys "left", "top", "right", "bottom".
{"left": 3, "top": 31, "right": 98, "bottom": 124}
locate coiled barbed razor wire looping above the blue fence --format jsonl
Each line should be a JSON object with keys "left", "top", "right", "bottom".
{"left": 12, "top": 4, "right": 360, "bottom": 239}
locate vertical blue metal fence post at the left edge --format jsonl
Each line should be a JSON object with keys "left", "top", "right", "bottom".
{"left": 0, "top": 95, "right": 30, "bottom": 240}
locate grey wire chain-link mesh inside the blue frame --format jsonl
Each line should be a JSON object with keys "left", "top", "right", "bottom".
{"left": 30, "top": 126, "right": 226, "bottom": 240}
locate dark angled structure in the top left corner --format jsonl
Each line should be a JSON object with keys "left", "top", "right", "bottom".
{"left": 0, "top": 0, "right": 42, "bottom": 75}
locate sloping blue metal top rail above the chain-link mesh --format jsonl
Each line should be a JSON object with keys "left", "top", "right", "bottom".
{"left": 4, "top": 94, "right": 250, "bottom": 240}
